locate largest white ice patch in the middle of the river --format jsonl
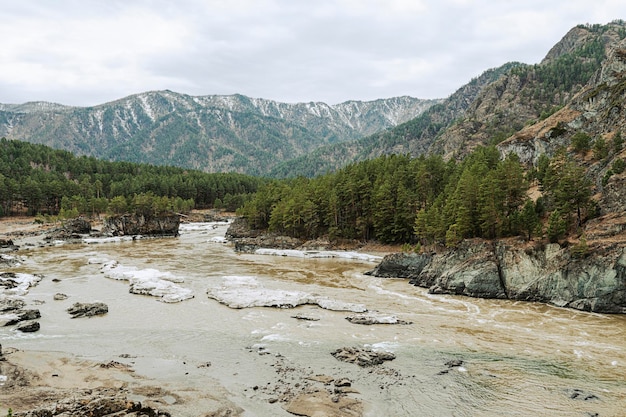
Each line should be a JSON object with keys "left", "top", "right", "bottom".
{"left": 207, "top": 276, "right": 367, "bottom": 313}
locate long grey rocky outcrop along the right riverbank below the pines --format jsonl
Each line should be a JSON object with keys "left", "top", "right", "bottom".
{"left": 370, "top": 237, "right": 626, "bottom": 314}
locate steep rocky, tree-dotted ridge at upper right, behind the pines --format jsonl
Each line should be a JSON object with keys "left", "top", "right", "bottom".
{"left": 278, "top": 20, "right": 626, "bottom": 175}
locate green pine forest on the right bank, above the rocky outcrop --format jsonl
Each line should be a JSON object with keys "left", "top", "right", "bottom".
{"left": 238, "top": 146, "right": 596, "bottom": 246}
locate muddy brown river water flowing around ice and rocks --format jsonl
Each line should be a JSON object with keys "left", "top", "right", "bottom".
{"left": 0, "top": 224, "right": 626, "bottom": 417}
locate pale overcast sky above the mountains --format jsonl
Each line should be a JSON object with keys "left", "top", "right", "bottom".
{"left": 0, "top": 0, "right": 626, "bottom": 106}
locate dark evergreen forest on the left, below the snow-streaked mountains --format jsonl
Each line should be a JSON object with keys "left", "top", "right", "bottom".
{"left": 0, "top": 138, "right": 263, "bottom": 216}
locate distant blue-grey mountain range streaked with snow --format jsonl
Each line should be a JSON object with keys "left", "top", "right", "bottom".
{"left": 0, "top": 91, "right": 438, "bottom": 174}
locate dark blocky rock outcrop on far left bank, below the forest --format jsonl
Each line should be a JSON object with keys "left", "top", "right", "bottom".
{"left": 103, "top": 214, "right": 180, "bottom": 237}
